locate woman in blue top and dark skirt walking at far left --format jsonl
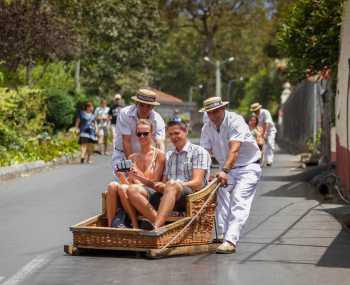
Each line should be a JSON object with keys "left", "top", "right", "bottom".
{"left": 75, "top": 102, "right": 97, "bottom": 163}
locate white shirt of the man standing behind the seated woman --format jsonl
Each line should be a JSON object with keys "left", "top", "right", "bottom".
{"left": 115, "top": 105, "right": 165, "bottom": 153}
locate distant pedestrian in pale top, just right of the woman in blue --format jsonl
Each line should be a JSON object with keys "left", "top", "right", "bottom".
{"left": 95, "top": 99, "right": 109, "bottom": 155}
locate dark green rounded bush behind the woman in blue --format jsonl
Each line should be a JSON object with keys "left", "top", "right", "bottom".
{"left": 46, "top": 89, "right": 75, "bottom": 129}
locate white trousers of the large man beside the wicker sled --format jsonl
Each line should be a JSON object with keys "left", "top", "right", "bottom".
{"left": 216, "top": 163, "right": 261, "bottom": 245}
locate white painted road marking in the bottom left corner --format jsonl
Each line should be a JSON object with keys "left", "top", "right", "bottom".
{"left": 0, "top": 254, "right": 49, "bottom": 285}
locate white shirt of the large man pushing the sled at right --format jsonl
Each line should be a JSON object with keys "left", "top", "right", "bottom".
{"left": 200, "top": 111, "right": 261, "bottom": 168}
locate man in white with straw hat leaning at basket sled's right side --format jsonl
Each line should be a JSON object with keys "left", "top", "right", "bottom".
{"left": 200, "top": 97, "right": 261, "bottom": 253}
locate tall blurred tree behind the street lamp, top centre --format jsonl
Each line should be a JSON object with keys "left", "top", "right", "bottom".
{"left": 156, "top": 0, "right": 278, "bottom": 96}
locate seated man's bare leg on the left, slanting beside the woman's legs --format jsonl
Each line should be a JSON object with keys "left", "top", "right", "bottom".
{"left": 127, "top": 187, "right": 157, "bottom": 223}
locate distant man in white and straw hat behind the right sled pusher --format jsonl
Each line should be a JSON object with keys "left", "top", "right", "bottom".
{"left": 250, "top": 103, "right": 277, "bottom": 166}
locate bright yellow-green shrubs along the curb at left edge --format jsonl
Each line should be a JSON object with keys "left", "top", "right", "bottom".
{"left": 0, "top": 87, "right": 78, "bottom": 166}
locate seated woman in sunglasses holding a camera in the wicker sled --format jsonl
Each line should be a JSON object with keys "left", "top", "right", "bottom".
{"left": 106, "top": 119, "right": 165, "bottom": 228}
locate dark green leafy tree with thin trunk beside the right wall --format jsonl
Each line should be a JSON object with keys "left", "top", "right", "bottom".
{"left": 278, "top": 0, "right": 344, "bottom": 166}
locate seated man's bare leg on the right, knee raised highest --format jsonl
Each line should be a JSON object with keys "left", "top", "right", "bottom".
{"left": 154, "top": 181, "right": 183, "bottom": 230}
